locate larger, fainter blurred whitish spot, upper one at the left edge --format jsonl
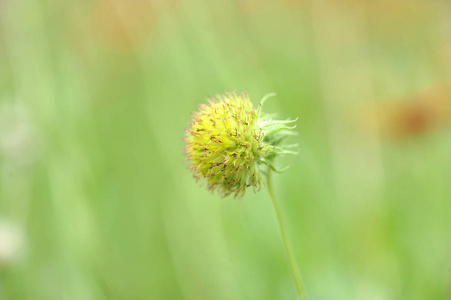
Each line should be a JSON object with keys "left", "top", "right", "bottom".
{"left": 0, "top": 101, "right": 34, "bottom": 166}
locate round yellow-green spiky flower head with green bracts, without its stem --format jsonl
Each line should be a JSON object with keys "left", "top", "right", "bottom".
{"left": 185, "top": 92, "right": 296, "bottom": 196}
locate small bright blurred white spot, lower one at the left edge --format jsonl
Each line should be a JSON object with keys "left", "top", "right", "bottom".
{"left": 0, "top": 219, "right": 24, "bottom": 267}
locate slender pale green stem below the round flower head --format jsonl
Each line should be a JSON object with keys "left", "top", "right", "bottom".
{"left": 266, "top": 171, "right": 307, "bottom": 300}
